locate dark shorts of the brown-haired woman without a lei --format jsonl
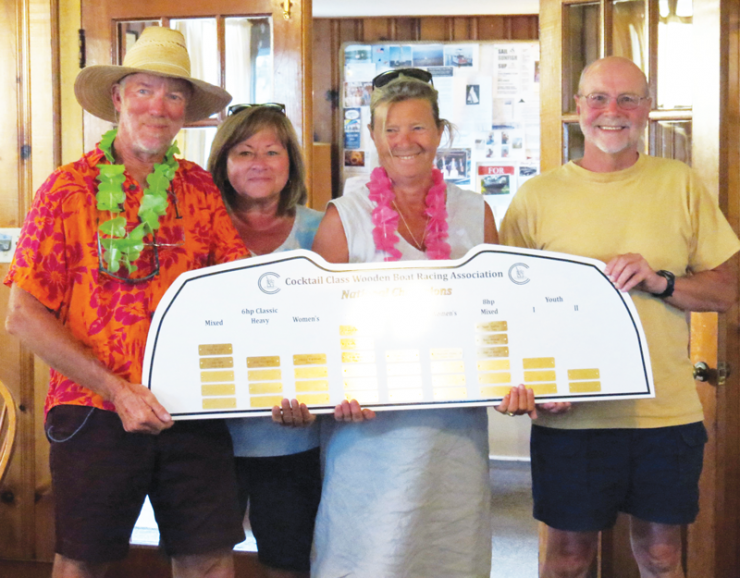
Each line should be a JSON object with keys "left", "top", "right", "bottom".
{"left": 235, "top": 448, "right": 321, "bottom": 572}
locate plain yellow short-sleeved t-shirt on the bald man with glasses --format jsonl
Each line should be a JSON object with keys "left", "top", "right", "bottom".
{"left": 500, "top": 155, "right": 740, "bottom": 429}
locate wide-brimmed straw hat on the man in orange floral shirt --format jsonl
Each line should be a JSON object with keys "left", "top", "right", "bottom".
{"left": 75, "top": 26, "right": 231, "bottom": 122}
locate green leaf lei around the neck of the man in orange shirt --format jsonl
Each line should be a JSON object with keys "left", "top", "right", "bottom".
{"left": 95, "top": 128, "right": 180, "bottom": 273}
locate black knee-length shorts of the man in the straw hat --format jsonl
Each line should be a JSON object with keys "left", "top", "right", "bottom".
{"left": 46, "top": 405, "right": 244, "bottom": 564}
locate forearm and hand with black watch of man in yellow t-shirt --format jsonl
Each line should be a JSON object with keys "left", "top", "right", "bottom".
{"left": 605, "top": 253, "right": 737, "bottom": 312}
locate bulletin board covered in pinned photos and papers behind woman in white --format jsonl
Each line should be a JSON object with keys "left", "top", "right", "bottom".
{"left": 340, "top": 41, "right": 540, "bottom": 224}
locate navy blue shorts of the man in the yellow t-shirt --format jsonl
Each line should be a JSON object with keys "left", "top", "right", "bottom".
{"left": 530, "top": 422, "right": 707, "bottom": 532}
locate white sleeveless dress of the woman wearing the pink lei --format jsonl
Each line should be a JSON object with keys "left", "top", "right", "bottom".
{"left": 311, "top": 179, "right": 491, "bottom": 578}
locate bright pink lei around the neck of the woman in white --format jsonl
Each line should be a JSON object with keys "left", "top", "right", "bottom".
{"left": 367, "top": 167, "right": 450, "bottom": 261}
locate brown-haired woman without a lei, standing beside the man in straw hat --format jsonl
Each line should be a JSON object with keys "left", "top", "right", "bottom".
{"left": 208, "top": 104, "right": 322, "bottom": 578}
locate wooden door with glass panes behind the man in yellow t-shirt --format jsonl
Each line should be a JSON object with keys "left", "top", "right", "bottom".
{"left": 540, "top": 0, "right": 740, "bottom": 578}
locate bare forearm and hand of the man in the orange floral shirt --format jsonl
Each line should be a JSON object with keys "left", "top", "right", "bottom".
{"left": 5, "top": 283, "right": 174, "bottom": 433}
